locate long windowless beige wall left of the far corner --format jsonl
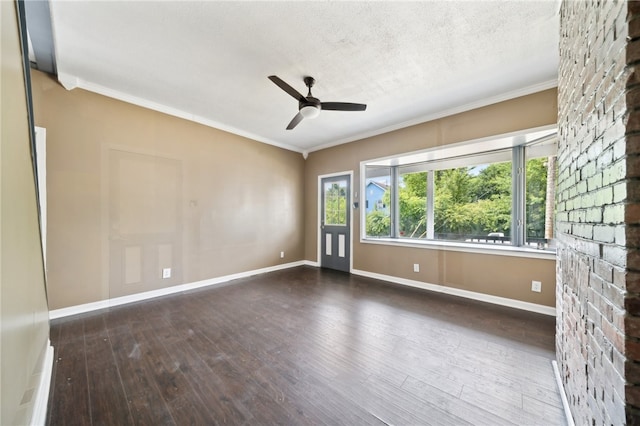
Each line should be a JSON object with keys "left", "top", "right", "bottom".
{"left": 32, "top": 71, "right": 304, "bottom": 309}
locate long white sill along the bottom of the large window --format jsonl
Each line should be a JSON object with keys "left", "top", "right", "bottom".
{"left": 360, "top": 238, "right": 556, "bottom": 260}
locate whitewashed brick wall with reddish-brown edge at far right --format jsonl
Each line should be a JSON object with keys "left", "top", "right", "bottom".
{"left": 556, "top": 0, "right": 640, "bottom": 425}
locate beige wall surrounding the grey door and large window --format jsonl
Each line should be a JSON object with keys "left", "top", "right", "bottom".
{"left": 305, "top": 89, "right": 558, "bottom": 306}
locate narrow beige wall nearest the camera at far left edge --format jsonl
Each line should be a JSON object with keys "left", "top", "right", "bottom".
{"left": 0, "top": 1, "right": 49, "bottom": 425}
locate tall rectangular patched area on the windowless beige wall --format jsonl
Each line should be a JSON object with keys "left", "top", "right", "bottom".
{"left": 103, "top": 148, "right": 184, "bottom": 297}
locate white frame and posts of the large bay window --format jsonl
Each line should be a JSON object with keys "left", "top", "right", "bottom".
{"left": 360, "top": 125, "right": 557, "bottom": 259}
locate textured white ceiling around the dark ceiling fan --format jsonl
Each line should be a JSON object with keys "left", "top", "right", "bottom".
{"left": 50, "top": 0, "right": 559, "bottom": 152}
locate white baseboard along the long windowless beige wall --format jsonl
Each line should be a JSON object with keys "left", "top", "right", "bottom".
{"left": 49, "top": 260, "right": 306, "bottom": 319}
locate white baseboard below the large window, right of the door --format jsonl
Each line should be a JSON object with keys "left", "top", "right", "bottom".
{"left": 351, "top": 269, "right": 556, "bottom": 316}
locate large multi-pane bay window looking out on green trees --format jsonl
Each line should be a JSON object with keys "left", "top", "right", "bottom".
{"left": 362, "top": 130, "right": 557, "bottom": 249}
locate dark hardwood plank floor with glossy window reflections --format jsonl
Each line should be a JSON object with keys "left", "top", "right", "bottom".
{"left": 47, "top": 267, "right": 565, "bottom": 425}
